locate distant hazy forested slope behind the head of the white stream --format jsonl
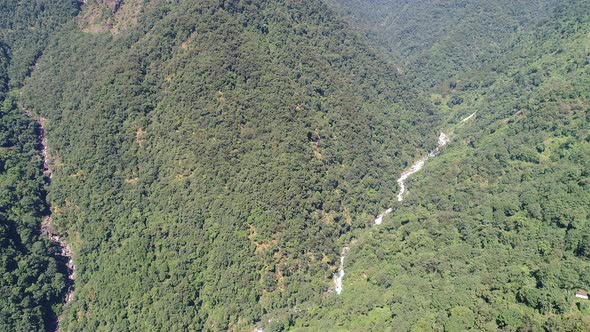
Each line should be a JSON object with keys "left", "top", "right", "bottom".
{"left": 331, "top": 0, "right": 571, "bottom": 87}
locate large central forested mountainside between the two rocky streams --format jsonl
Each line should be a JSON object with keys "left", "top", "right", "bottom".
{"left": 22, "top": 1, "right": 440, "bottom": 331}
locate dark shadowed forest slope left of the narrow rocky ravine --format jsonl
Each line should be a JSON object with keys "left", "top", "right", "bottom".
{"left": 0, "top": 102, "right": 66, "bottom": 331}
